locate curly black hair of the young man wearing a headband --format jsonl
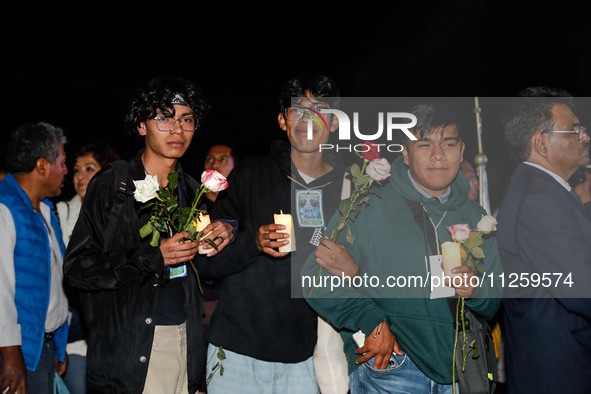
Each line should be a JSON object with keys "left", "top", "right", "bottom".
{"left": 125, "top": 77, "right": 210, "bottom": 135}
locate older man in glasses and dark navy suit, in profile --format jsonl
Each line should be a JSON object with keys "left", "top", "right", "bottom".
{"left": 497, "top": 87, "right": 591, "bottom": 394}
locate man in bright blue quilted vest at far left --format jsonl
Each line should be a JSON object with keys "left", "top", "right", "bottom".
{"left": 0, "top": 123, "right": 68, "bottom": 393}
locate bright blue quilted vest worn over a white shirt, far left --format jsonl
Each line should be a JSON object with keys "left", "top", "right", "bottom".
{"left": 0, "top": 174, "right": 68, "bottom": 371}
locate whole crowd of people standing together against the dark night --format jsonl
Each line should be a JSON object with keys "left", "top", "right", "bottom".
{"left": 0, "top": 75, "right": 591, "bottom": 394}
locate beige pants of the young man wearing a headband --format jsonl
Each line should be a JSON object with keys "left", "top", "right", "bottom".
{"left": 144, "top": 323, "right": 189, "bottom": 394}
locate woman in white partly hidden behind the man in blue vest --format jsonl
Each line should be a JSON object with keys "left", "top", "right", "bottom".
{"left": 56, "top": 142, "right": 119, "bottom": 394}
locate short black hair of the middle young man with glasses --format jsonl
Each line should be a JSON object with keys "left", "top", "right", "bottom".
{"left": 279, "top": 74, "right": 340, "bottom": 113}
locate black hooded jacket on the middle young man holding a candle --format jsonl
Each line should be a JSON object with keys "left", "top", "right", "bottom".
{"left": 199, "top": 141, "right": 344, "bottom": 363}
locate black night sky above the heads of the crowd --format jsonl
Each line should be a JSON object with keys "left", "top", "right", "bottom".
{"left": 0, "top": 0, "right": 591, "bottom": 211}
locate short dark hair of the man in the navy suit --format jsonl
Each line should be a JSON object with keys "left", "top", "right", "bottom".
{"left": 503, "top": 86, "right": 575, "bottom": 162}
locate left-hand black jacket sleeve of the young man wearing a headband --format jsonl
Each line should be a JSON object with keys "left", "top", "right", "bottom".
{"left": 64, "top": 168, "right": 164, "bottom": 290}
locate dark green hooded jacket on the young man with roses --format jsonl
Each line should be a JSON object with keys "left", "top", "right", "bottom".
{"left": 302, "top": 157, "right": 502, "bottom": 384}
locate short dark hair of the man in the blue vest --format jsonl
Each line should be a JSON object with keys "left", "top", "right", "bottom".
{"left": 6, "top": 122, "right": 67, "bottom": 174}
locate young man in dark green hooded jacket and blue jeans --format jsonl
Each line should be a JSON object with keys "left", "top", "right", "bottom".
{"left": 302, "top": 105, "right": 501, "bottom": 393}
